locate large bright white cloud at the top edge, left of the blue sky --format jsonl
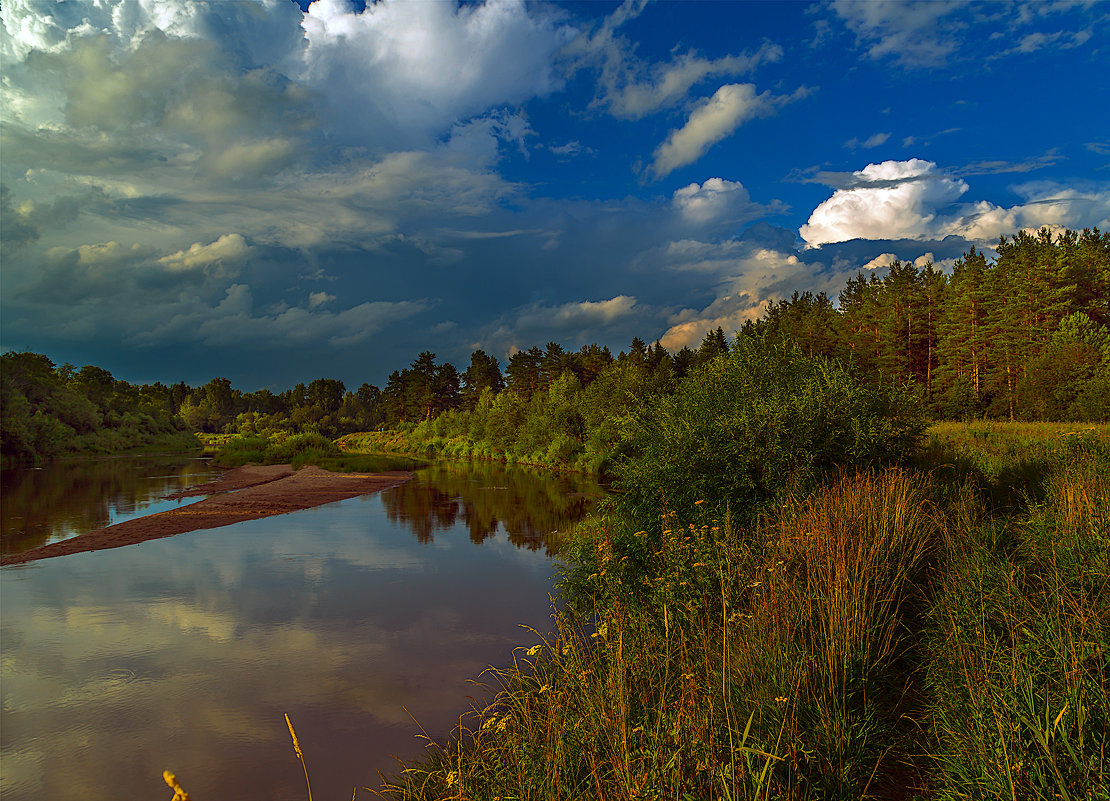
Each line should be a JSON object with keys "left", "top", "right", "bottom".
{"left": 302, "top": 0, "right": 577, "bottom": 145}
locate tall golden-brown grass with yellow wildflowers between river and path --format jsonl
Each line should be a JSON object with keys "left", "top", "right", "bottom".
{"left": 387, "top": 470, "right": 938, "bottom": 799}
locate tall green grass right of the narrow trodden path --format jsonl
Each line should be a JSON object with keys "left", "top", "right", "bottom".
{"left": 927, "top": 445, "right": 1110, "bottom": 799}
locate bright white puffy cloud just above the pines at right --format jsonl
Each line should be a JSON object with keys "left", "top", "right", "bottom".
{"left": 799, "top": 159, "right": 968, "bottom": 246}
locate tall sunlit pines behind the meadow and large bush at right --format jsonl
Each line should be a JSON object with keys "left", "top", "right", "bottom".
{"left": 745, "top": 229, "right": 1110, "bottom": 420}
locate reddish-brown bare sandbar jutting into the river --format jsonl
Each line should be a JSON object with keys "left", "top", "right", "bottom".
{"left": 0, "top": 465, "right": 413, "bottom": 566}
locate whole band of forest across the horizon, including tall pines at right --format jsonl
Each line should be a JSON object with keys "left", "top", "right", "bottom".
{"left": 0, "top": 229, "right": 1110, "bottom": 464}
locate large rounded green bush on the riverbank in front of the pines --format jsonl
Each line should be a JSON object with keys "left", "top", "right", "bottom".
{"left": 614, "top": 338, "right": 925, "bottom": 516}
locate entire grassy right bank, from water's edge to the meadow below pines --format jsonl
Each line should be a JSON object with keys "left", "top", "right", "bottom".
{"left": 381, "top": 423, "right": 1110, "bottom": 801}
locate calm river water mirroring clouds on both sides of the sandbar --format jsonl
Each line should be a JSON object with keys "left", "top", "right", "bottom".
{"left": 0, "top": 460, "right": 599, "bottom": 801}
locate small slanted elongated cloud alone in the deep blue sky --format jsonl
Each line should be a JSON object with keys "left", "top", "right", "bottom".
{"left": 649, "top": 83, "right": 784, "bottom": 178}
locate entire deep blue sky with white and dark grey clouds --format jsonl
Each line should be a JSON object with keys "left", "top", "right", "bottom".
{"left": 0, "top": 0, "right": 1110, "bottom": 391}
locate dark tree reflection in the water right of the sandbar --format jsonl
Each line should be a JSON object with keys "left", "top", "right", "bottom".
{"left": 382, "top": 463, "right": 604, "bottom": 555}
